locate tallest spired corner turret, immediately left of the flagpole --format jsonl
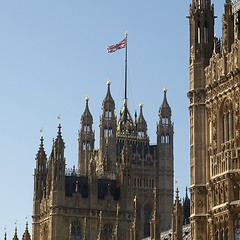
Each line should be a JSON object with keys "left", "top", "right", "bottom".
{"left": 99, "top": 81, "right": 117, "bottom": 173}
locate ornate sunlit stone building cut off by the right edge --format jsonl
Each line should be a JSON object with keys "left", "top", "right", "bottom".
{"left": 188, "top": 0, "right": 240, "bottom": 240}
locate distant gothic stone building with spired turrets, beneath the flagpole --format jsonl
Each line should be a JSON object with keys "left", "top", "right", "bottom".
{"left": 32, "top": 82, "right": 173, "bottom": 240}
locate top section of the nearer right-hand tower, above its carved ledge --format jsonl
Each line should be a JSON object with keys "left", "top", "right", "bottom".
{"left": 189, "top": 0, "right": 214, "bottom": 89}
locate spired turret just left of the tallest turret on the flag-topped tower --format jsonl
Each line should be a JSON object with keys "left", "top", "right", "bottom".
{"left": 78, "top": 97, "right": 94, "bottom": 175}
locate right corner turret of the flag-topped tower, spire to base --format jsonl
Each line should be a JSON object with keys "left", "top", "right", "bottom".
{"left": 157, "top": 89, "right": 174, "bottom": 232}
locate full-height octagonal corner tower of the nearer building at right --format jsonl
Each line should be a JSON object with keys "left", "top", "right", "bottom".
{"left": 188, "top": 0, "right": 214, "bottom": 239}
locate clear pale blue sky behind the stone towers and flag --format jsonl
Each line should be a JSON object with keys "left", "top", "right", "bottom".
{"left": 0, "top": 0, "right": 224, "bottom": 238}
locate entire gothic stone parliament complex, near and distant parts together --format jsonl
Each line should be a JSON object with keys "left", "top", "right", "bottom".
{"left": 4, "top": 0, "right": 240, "bottom": 240}
